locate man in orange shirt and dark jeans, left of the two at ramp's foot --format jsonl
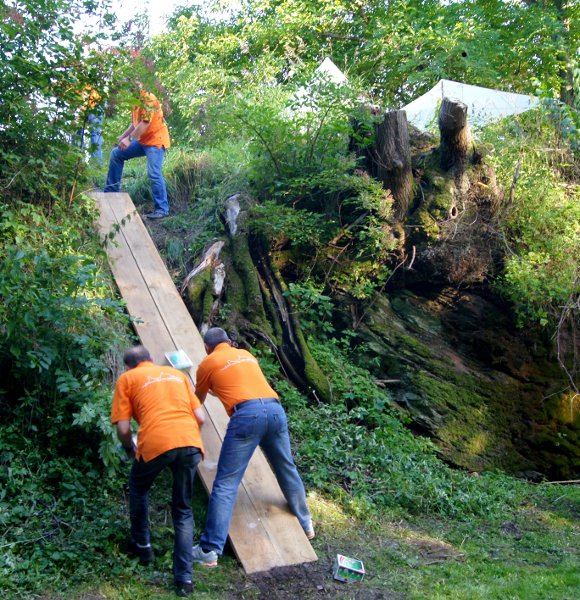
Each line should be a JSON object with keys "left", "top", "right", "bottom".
{"left": 111, "top": 346, "right": 204, "bottom": 596}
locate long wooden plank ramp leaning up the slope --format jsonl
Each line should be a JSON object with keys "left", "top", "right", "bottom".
{"left": 92, "top": 192, "right": 317, "bottom": 573}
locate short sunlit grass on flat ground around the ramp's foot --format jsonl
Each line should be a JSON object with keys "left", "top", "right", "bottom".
{"left": 66, "top": 488, "right": 580, "bottom": 600}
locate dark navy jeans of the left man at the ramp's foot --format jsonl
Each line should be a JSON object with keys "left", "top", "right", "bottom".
{"left": 129, "top": 446, "right": 201, "bottom": 582}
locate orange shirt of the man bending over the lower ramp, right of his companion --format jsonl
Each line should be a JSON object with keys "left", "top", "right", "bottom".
{"left": 195, "top": 342, "right": 278, "bottom": 416}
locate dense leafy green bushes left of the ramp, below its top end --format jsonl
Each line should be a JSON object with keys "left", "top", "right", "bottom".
{"left": 0, "top": 197, "right": 138, "bottom": 597}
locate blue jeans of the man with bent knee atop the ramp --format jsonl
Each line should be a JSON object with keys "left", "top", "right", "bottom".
{"left": 105, "top": 140, "right": 169, "bottom": 215}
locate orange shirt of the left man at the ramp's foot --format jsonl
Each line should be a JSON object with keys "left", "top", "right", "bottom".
{"left": 111, "top": 361, "right": 203, "bottom": 462}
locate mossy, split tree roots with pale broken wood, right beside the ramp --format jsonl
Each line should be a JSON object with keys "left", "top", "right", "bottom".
{"left": 182, "top": 194, "right": 330, "bottom": 400}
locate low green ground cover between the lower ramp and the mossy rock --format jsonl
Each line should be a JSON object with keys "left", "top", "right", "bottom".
{"left": 261, "top": 338, "right": 525, "bottom": 519}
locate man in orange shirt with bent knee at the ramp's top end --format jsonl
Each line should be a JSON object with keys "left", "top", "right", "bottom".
{"left": 105, "top": 81, "right": 171, "bottom": 219}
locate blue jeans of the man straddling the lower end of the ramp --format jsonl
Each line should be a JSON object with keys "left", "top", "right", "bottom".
{"left": 200, "top": 398, "right": 311, "bottom": 554}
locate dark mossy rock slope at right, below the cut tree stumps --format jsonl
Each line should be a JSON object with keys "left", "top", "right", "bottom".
{"left": 358, "top": 288, "right": 580, "bottom": 479}
